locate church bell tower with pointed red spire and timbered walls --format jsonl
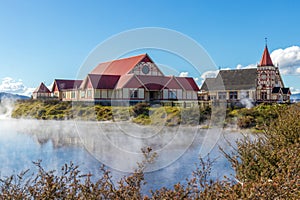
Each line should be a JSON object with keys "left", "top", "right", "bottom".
{"left": 256, "top": 39, "right": 284, "bottom": 102}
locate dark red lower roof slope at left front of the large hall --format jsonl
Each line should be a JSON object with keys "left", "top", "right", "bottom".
{"left": 88, "top": 74, "right": 120, "bottom": 89}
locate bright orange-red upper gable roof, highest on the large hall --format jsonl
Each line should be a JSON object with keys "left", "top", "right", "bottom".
{"left": 91, "top": 54, "right": 152, "bottom": 75}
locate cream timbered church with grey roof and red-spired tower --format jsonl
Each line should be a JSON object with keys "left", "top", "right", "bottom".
{"left": 199, "top": 45, "right": 291, "bottom": 103}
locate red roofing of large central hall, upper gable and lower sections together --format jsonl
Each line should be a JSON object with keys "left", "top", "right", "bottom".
{"left": 67, "top": 54, "right": 199, "bottom": 91}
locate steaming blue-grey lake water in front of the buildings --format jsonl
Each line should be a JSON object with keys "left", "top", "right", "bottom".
{"left": 0, "top": 119, "right": 241, "bottom": 191}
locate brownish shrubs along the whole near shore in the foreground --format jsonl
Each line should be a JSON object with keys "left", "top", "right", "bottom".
{"left": 0, "top": 104, "right": 300, "bottom": 199}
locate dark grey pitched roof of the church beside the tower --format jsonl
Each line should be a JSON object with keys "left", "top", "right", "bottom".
{"left": 201, "top": 68, "right": 257, "bottom": 91}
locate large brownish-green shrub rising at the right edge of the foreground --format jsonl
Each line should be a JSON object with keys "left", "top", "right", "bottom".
{"left": 219, "top": 105, "right": 300, "bottom": 199}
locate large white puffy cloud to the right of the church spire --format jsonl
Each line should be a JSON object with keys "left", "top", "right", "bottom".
{"left": 271, "top": 46, "right": 300, "bottom": 75}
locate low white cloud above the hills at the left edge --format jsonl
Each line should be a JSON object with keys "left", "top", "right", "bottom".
{"left": 0, "top": 77, "right": 35, "bottom": 96}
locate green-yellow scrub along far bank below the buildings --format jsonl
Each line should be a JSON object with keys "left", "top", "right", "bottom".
{"left": 12, "top": 100, "right": 288, "bottom": 130}
